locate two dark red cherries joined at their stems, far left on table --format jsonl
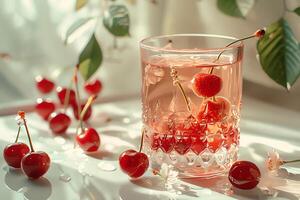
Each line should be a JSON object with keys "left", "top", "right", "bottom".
{"left": 3, "top": 111, "right": 50, "bottom": 179}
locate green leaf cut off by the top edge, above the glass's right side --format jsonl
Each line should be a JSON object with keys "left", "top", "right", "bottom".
{"left": 217, "top": 0, "right": 255, "bottom": 18}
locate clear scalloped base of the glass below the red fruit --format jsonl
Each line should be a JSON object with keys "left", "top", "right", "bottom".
{"left": 143, "top": 143, "right": 238, "bottom": 178}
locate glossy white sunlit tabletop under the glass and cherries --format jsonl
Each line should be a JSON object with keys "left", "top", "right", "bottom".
{"left": 0, "top": 97, "right": 300, "bottom": 200}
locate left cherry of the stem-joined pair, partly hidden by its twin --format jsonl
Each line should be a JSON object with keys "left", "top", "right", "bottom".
{"left": 3, "top": 142, "right": 30, "bottom": 168}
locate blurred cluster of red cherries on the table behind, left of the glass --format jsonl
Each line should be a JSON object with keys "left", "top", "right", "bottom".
{"left": 35, "top": 75, "right": 102, "bottom": 152}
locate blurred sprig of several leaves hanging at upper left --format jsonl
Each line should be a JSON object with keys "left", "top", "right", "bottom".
{"left": 64, "top": 0, "right": 130, "bottom": 81}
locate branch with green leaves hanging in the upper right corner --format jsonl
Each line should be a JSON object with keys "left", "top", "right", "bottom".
{"left": 217, "top": 0, "right": 300, "bottom": 90}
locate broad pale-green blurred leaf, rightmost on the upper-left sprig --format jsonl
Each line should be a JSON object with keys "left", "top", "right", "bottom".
{"left": 103, "top": 5, "right": 129, "bottom": 36}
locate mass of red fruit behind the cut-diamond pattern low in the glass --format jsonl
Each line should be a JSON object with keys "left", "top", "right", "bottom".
{"left": 150, "top": 116, "right": 239, "bottom": 155}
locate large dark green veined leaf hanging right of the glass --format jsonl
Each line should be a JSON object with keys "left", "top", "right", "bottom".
{"left": 257, "top": 19, "right": 300, "bottom": 89}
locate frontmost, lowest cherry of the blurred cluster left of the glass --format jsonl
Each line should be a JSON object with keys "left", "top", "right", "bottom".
{"left": 76, "top": 128, "right": 100, "bottom": 152}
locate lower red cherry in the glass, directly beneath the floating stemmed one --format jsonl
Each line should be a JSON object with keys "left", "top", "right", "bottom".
{"left": 197, "top": 97, "right": 231, "bottom": 123}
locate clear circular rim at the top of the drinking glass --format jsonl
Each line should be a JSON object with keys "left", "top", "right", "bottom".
{"left": 139, "top": 33, "right": 244, "bottom": 53}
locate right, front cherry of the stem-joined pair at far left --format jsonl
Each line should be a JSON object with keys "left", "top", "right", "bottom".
{"left": 21, "top": 151, "right": 50, "bottom": 179}
